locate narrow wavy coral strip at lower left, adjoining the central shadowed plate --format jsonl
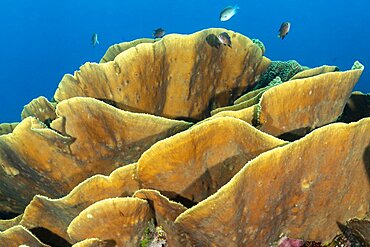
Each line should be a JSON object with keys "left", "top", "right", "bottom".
{"left": 0, "top": 164, "right": 140, "bottom": 241}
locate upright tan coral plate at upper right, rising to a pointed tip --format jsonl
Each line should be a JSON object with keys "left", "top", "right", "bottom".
{"left": 255, "top": 61, "right": 364, "bottom": 136}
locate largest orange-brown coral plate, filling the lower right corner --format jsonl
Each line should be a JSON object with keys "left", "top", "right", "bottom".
{"left": 175, "top": 118, "right": 370, "bottom": 246}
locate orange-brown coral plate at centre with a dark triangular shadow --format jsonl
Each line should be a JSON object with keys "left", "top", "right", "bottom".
{"left": 137, "top": 118, "right": 285, "bottom": 206}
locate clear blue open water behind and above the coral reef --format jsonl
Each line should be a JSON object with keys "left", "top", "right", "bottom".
{"left": 0, "top": 0, "right": 370, "bottom": 123}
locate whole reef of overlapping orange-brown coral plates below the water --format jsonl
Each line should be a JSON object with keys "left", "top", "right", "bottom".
{"left": 0, "top": 28, "right": 370, "bottom": 247}
